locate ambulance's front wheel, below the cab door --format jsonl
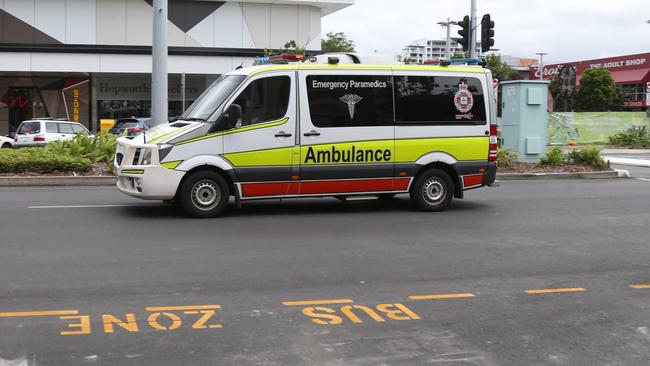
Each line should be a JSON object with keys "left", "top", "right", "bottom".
{"left": 177, "top": 171, "right": 230, "bottom": 218}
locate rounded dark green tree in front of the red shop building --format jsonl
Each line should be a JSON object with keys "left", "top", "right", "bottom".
{"left": 576, "top": 67, "right": 621, "bottom": 112}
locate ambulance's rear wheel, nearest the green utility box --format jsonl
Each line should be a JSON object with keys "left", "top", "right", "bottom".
{"left": 409, "top": 169, "right": 454, "bottom": 212}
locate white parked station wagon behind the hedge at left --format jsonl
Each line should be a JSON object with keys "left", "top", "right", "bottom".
{"left": 13, "top": 119, "right": 90, "bottom": 147}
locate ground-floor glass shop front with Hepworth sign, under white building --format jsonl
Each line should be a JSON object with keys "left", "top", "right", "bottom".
{"left": 0, "top": 73, "right": 218, "bottom": 135}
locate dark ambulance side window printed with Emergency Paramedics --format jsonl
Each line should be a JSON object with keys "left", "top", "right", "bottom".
{"left": 307, "top": 75, "right": 393, "bottom": 127}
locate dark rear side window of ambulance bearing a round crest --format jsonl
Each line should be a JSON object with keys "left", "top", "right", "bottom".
{"left": 395, "top": 76, "right": 486, "bottom": 124}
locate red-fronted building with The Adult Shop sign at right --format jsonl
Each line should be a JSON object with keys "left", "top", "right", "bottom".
{"left": 528, "top": 53, "right": 650, "bottom": 110}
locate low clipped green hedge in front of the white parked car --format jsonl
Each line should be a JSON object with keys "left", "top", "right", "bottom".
{"left": 0, "top": 147, "right": 92, "bottom": 173}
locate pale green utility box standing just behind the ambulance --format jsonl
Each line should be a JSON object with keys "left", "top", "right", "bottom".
{"left": 501, "top": 80, "right": 549, "bottom": 163}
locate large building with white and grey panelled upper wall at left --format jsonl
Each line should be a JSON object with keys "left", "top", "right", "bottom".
{"left": 0, "top": 0, "right": 354, "bottom": 135}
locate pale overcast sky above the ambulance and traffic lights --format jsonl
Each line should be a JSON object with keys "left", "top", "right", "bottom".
{"left": 322, "top": 0, "right": 650, "bottom": 63}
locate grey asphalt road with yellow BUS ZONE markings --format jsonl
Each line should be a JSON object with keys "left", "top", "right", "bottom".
{"left": 0, "top": 179, "right": 650, "bottom": 366}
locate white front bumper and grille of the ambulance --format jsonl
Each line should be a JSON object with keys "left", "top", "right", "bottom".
{"left": 113, "top": 138, "right": 185, "bottom": 200}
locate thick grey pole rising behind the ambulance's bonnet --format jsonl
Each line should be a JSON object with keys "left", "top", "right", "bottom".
{"left": 151, "top": 0, "right": 169, "bottom": 125}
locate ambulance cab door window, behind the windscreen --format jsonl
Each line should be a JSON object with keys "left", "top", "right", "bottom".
{"left": 233, "top": 76, "right": 291, "bottom": 126}
